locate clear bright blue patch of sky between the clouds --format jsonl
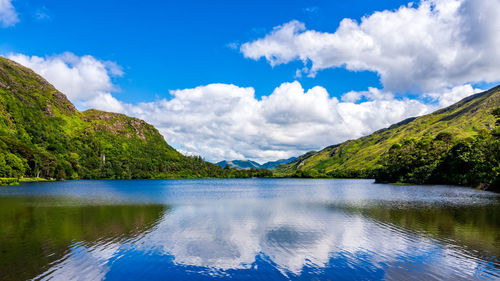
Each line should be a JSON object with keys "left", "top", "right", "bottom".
{"left": 0, "top": 0, "right": 414, "bottom": 102}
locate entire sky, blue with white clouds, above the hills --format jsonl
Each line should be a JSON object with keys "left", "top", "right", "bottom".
{"left": 0, "top": 0, "right": 500, "bottom": 162}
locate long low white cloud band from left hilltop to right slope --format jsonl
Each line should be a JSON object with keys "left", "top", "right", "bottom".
{"left": 9, "top": 53, "right": 477, "bottom": 162}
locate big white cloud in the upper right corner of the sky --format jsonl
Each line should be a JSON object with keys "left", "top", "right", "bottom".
{"left": 240, "top": 0, "right": 500, "bottom": 92}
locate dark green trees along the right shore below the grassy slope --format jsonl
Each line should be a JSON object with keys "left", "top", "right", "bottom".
{"left": 375, "top": 107, "right": 500, "bottom": 191}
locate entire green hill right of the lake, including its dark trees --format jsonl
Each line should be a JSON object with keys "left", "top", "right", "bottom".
{"left": 274, "top": 86, "right": 500, "bottom": 189}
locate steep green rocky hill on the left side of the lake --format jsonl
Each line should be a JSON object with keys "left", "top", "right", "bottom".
{"left": 0, "top": 57, "right": 235, "bottom": 179}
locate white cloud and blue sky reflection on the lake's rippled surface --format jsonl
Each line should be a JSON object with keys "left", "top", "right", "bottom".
{"left": 123, "top": 202, "right": 499, "bottom": 280}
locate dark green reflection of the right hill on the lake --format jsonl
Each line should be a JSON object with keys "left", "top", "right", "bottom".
{"left": 338, "top": 200, "right": 500, "bottom": 257}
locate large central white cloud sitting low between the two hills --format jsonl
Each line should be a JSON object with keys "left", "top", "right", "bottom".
{"left": 123, "top": 82, "right": 435, "bottom": 162}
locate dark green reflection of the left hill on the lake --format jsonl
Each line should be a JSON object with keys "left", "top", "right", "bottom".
{"left": 0, "top": 197, "right": 166, "bottom": 280}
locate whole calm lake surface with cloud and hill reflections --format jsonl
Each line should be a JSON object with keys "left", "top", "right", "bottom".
{"left": 0, "top": 179, "right": 500, "bottom": 280}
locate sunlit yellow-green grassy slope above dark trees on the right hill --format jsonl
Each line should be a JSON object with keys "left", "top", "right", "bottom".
{"left": 274, "top": 87, "right": 500, "bottom": 177}
